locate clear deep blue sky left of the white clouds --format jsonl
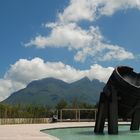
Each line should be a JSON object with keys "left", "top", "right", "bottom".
{"left": 0, "top": 0, "right": 66, "bottom": 76}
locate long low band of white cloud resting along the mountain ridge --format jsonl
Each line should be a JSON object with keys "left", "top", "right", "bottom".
{"left": 0, "top": 58, "right": 113, "bottom": 101}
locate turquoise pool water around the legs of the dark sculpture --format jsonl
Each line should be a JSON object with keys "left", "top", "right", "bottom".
{"left": 42, "top": 126, "right": 140, "bottom": 140}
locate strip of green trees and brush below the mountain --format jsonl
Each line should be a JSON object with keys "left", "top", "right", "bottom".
{"left": 0, "top": 99, "right": 96, "bottom": 118}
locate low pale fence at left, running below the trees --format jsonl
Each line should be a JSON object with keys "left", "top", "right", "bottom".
{"left": 0, "top": 118, "right": 52, "bottom": 125}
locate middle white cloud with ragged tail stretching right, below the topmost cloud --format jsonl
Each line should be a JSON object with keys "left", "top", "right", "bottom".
{"left": 26, "top": 23, "right": 134, "bottom": 62}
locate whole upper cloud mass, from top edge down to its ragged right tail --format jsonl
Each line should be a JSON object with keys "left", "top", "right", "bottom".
{"left": 25, "top": 0, "right": 137, "bottom": 62}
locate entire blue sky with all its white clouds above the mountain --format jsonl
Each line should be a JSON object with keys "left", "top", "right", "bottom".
{"left": 0, "top": 0, "right": 140, "bottom": 100}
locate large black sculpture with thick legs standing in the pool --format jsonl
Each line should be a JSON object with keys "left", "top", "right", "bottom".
{"left": 94, "top": 66, "right": 140, "bottom": 134}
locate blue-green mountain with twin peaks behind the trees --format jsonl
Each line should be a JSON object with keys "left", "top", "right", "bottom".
{"left": 3, "top": 77, "right": 105, "bottom": 106}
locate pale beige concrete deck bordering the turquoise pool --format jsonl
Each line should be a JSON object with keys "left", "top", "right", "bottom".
{"left": 0, "top": 122, "right": 130, "bottom": 140}
